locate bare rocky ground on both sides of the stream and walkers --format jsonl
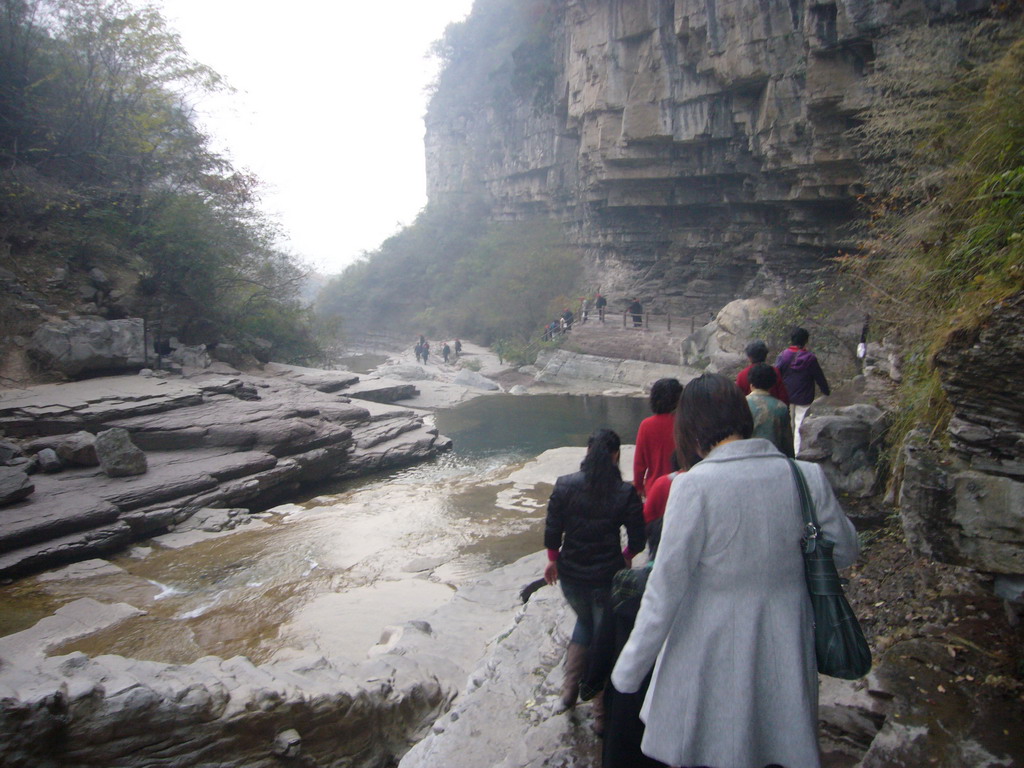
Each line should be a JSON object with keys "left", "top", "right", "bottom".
{"left": 0, "top": 333, "right": 1024, "bottom": 768}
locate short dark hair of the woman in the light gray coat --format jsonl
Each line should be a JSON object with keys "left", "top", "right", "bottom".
{"left": 676, "top": 374, "right": 754, "bottom": 469}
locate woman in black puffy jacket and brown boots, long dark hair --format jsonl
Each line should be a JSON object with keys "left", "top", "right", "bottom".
{"left": 544, "top": 429, "right": 645, "bottom": 709}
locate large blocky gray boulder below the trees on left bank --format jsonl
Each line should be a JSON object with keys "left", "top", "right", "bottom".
{"left": 28, "top": 317, "right": 145, "bottom": 378}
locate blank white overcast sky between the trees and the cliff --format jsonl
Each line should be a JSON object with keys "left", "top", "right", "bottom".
{"left": 157, "top": 0, "right": 472, "bottom": 273}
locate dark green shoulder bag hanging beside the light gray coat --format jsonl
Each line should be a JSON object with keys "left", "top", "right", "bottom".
{"left": 787, "top": 459, "right": 871, "bottom": 680}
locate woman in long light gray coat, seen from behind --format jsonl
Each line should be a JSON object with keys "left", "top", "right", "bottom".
{"left": 611, "top": 375, "right": 858, "bottom": 768}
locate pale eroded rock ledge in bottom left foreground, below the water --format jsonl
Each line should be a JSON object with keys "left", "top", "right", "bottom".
{"left": 0, "top": 553, "right": 544, "bottom": 768}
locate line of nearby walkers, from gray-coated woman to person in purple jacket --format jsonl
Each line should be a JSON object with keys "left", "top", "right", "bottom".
{"left": 544, "top": 329, "right": 843, "bottom": 768}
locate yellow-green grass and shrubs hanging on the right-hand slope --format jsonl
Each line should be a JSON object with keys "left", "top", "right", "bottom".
{"left": 845, "top": 18, "right": 1024, "bottom": 456}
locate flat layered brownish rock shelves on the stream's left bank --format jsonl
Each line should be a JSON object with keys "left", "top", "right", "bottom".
{"left": 0, "top": 372, "right": 451, "bottom": 577}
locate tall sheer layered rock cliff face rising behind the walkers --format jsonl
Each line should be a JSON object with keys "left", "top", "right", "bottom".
{"left": 426, "top": 0, "right": 989, "bottom": 314}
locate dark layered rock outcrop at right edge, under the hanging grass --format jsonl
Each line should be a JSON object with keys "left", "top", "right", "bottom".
{"left": 900, "top": 294, "right": 1024, "bottom": 578}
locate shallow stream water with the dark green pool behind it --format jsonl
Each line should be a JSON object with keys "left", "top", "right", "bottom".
{"left": 0, "top": 395, "right": 649, "bottom": 664}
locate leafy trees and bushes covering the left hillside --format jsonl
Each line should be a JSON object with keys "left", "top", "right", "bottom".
{"left": 0, "top": 0, "right": 315, "bottom": 358}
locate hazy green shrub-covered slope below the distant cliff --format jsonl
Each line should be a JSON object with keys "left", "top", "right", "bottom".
{"left": 317, "top": 205, "right": 580, "bottom": 344}
